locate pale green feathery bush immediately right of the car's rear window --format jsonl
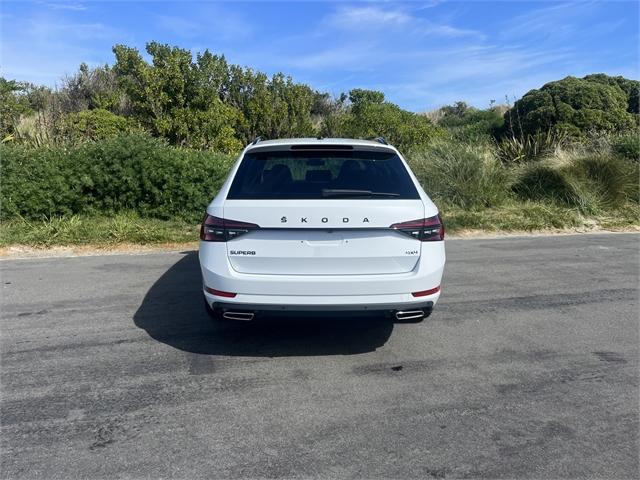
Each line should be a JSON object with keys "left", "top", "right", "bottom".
{"left": 410, "top": 140, "right": 510, "bottom": 209}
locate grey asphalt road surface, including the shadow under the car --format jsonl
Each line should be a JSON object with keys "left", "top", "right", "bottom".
{"left": 0, "top": 234, "right": 640, "bottom": 479}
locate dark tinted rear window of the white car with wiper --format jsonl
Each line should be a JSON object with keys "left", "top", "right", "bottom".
{"left": 227, "top": 150, "right": 420, "bottom": 200}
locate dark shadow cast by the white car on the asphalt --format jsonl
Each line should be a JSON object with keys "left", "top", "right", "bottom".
{"left": 133, "top": 252, "right": 394, "bottom": 357}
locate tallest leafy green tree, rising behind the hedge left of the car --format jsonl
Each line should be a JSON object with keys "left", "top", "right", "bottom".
{"left": 114, "top": 42, "right": 244, "bottom": 152}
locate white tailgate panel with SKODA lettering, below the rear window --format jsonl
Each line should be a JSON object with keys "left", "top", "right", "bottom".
{"left": 224, "top": 199, "right": 424, "bottom": 275}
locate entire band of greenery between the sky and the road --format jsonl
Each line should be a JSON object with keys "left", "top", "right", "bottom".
{"left": 0, "top": 42, "right": 640, "bottom": 246}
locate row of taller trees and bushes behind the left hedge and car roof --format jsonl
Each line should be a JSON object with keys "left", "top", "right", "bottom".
{"left": 0, "top": 42, "right": 438, "bottom": 153}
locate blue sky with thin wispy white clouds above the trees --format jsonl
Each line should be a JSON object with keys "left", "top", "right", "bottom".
{"left": 0, "top": 0, "right": 640, "bottom": 111}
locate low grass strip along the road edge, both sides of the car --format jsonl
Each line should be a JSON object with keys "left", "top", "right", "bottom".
{"left": 0, "top": 202, "right": 640, "bottom": 248}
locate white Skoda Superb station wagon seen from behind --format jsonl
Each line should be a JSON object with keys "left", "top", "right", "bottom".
{"left": 200, "top": 139, "right": 445, "bottom": 320}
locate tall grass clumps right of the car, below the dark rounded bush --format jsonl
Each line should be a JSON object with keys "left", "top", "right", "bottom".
{"left": 410, "top": 134, "right": 640, "bottom": 214}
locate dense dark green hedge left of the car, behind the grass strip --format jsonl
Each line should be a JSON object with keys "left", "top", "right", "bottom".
{"left": 0, "top": 134, "right": 233, "bottom": 222}
